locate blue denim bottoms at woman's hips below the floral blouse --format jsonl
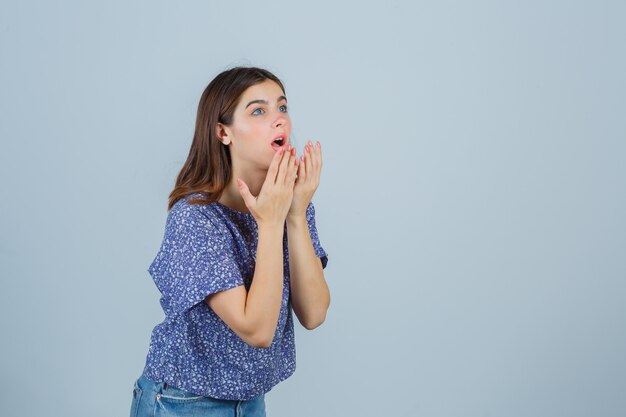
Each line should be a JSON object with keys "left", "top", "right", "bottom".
{"left": 130, "top": 375, "right": 266, "bottom": 417}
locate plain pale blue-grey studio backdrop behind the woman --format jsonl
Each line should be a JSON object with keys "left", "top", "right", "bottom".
{"left": 0, "top": 0, "right": 626, "bottom": 417}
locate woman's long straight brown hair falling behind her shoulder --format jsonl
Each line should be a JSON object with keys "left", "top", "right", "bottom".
{"left": 167, "top": 67, "right": 286, "bottom": 211}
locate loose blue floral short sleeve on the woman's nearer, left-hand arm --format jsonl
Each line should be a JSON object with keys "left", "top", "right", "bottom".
{"left": 148, "top": 200, "right": 244, "bottom": 317}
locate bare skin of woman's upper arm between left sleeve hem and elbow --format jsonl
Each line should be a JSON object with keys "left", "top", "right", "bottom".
{"left": 206, "top": 285, "right": 267, "bottom": 348}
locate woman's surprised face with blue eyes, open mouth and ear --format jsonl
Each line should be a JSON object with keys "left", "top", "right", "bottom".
{"left": 222, "top": 80, "right": 291, "bottom": 169}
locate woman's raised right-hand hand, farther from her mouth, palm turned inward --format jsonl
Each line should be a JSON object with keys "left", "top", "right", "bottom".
{"left": 287, "top": 141, "right": 322, "bottom": 218}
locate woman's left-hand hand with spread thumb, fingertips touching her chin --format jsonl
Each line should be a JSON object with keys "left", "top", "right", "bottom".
{"left": 237, "top": 145, "right": 298, "bottom": 226}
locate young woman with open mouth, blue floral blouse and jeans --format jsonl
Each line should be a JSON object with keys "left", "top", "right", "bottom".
{"left": 130, "top": 67, "right": 330, "bottom": 417}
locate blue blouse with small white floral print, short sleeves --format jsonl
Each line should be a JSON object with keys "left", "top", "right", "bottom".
{"left": 143, "top": 194, "right": 328, "bottom": 400}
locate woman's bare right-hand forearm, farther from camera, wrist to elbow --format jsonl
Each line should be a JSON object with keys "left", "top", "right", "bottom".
{"left": 287, "top": 215, "right": 330, "bottom": 330}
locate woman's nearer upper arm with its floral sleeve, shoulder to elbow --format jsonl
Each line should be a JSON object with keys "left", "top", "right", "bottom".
{"left": 148, "top": 202, "right": 256, "bottom": 346}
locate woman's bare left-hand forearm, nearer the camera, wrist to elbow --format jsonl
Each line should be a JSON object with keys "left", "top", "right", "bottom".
{"left": 245, "top": 224, "right": 284, "bottom": 346}
